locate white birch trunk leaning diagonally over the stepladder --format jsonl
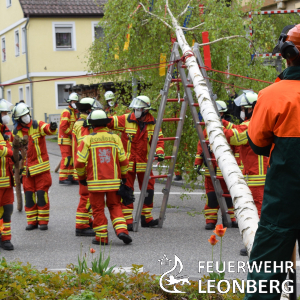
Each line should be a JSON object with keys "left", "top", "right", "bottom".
{"left": 166, "top": 0, "right": 259, "bottom": 254}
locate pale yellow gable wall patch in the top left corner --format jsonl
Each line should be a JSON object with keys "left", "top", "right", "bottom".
{"left": 0, "top": 0, "right": 24, "bottom": 31}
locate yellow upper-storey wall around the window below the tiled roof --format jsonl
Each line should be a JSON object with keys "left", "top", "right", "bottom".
{"left": 28, "top": 18, "right": 99, "bottom": 72}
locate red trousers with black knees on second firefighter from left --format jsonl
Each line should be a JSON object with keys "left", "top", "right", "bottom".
{"left": 23, "top": 171, "right": 52, "bottom": 225}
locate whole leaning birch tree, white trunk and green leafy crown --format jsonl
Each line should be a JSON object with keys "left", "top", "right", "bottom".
{"left": 88, "top": 0, "right": 300, "bottom": 254}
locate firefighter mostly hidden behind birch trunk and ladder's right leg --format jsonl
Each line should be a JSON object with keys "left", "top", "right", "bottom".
{"left": 194, "top": 100, "right": 238, "bottom": 230}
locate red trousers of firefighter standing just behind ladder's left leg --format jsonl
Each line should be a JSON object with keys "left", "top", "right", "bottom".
{"left": 122, "top": 171, "right": 155, "bottom": 224}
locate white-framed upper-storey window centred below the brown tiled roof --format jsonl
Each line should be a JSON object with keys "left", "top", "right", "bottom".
{"left": 53, "top": 22, "right": 76, "bottom": 51}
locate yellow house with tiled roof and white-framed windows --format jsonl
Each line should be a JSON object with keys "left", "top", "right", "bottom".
{"left": 0, "top": 0, "right": 105, "bottom": 120}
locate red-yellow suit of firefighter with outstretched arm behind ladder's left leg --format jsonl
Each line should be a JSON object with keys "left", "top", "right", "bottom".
{"left": 107, "top": 113, "right": 164, "bottom": 224}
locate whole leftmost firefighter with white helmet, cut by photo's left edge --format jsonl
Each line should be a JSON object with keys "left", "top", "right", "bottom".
{"left": 0, "top": 99, "right": 17, "bottom": 250}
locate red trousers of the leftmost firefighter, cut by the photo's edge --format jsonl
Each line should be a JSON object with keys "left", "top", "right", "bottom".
{"left": 0, "top": 187, "right": 14, "bottom": 241}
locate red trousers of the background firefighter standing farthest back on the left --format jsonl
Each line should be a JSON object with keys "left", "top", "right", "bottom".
{"left": 59, "top": 145, "right": 78, "bottom": 181}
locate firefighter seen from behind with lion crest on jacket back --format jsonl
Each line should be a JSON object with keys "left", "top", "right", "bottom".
{"left": 75, "top": 109, "right": 132, "bottom": 245}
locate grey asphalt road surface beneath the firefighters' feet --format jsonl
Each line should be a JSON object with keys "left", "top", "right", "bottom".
{"left": 0, "top": 142, "right": 300, "bottom": 296}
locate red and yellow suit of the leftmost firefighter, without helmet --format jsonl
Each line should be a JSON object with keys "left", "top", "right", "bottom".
{"left": 0, "top": 123, "right": 14, "bottom": 241}
